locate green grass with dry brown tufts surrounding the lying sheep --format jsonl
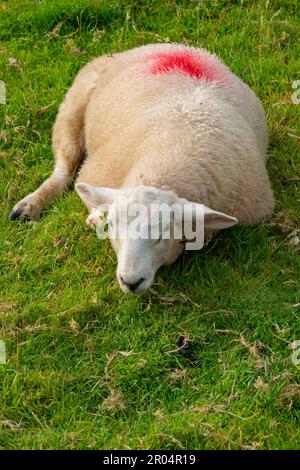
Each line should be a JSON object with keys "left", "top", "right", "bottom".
{"left": 0, "top": 0, "right": 300, "bottom": 449}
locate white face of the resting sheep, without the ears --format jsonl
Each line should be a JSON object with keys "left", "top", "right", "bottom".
{"left": 107, "top": 188, "right": 184, "bottom": 293}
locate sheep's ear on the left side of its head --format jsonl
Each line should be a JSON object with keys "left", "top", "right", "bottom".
{"left": 75, "top": 183, "right": 119, "bottom": 208}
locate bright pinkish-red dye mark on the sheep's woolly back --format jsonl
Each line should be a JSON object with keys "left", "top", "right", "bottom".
{"left": 148, "top": 51, "right": 230, "bottom": 85}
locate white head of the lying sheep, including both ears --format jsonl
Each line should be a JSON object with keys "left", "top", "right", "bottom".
{"left": 75, "top": 183, "right": 237, "bottom": 294}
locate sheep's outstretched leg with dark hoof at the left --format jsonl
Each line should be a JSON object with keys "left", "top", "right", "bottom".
{"left": 9, "top": 59, "right": 101, "bottom": 220}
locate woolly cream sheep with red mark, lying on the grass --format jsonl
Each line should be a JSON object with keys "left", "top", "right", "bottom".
{"left": 10, "top": 44, "right": 274, "bottom": 294}
